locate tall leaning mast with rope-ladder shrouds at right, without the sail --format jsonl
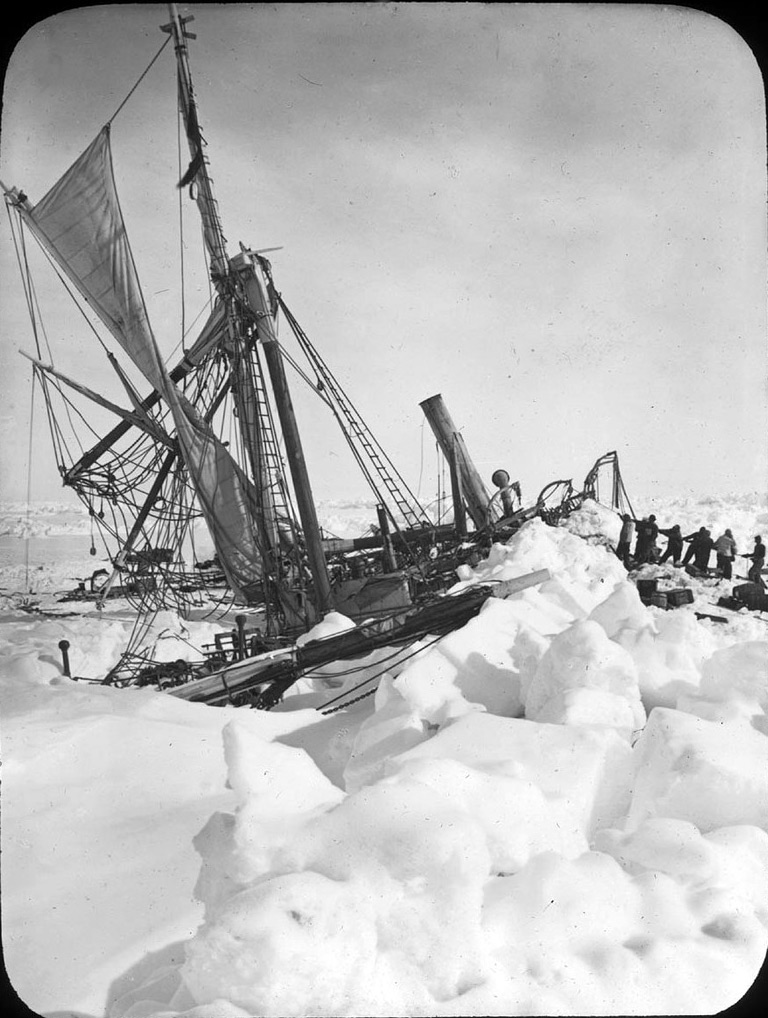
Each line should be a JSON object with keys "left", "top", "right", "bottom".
{"left": 158, "top": 4, "right": 431, "bottom": 624}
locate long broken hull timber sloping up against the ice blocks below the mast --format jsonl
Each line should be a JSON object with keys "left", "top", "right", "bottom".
{"left": 167, "top": 569, "right": 550, "bottom": 708}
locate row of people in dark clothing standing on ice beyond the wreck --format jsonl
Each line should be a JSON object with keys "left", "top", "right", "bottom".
{"left": 616, "top": 513, "right": 765, "bottom": 586}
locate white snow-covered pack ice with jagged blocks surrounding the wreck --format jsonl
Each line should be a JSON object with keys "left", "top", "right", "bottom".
{"left": 0, "top": 498, "right": 768, "bottom": 1018}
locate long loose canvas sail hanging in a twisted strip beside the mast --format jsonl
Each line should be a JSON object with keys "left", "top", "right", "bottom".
{"left": 24, "top": 126, "right": 264, "bottom": 601}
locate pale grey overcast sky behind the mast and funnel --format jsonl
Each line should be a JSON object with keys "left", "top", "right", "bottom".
{"left": 0, "top": 3, "right": 768, "bottom": 509}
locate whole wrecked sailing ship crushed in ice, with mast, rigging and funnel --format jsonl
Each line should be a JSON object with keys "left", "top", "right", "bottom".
{"left": 3, "top": 4, "right": 628, "bottom": 706}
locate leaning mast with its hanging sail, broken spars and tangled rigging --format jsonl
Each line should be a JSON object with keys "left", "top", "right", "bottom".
{"left": 4, "top": 4, "right": 431, "bottom": 632}
